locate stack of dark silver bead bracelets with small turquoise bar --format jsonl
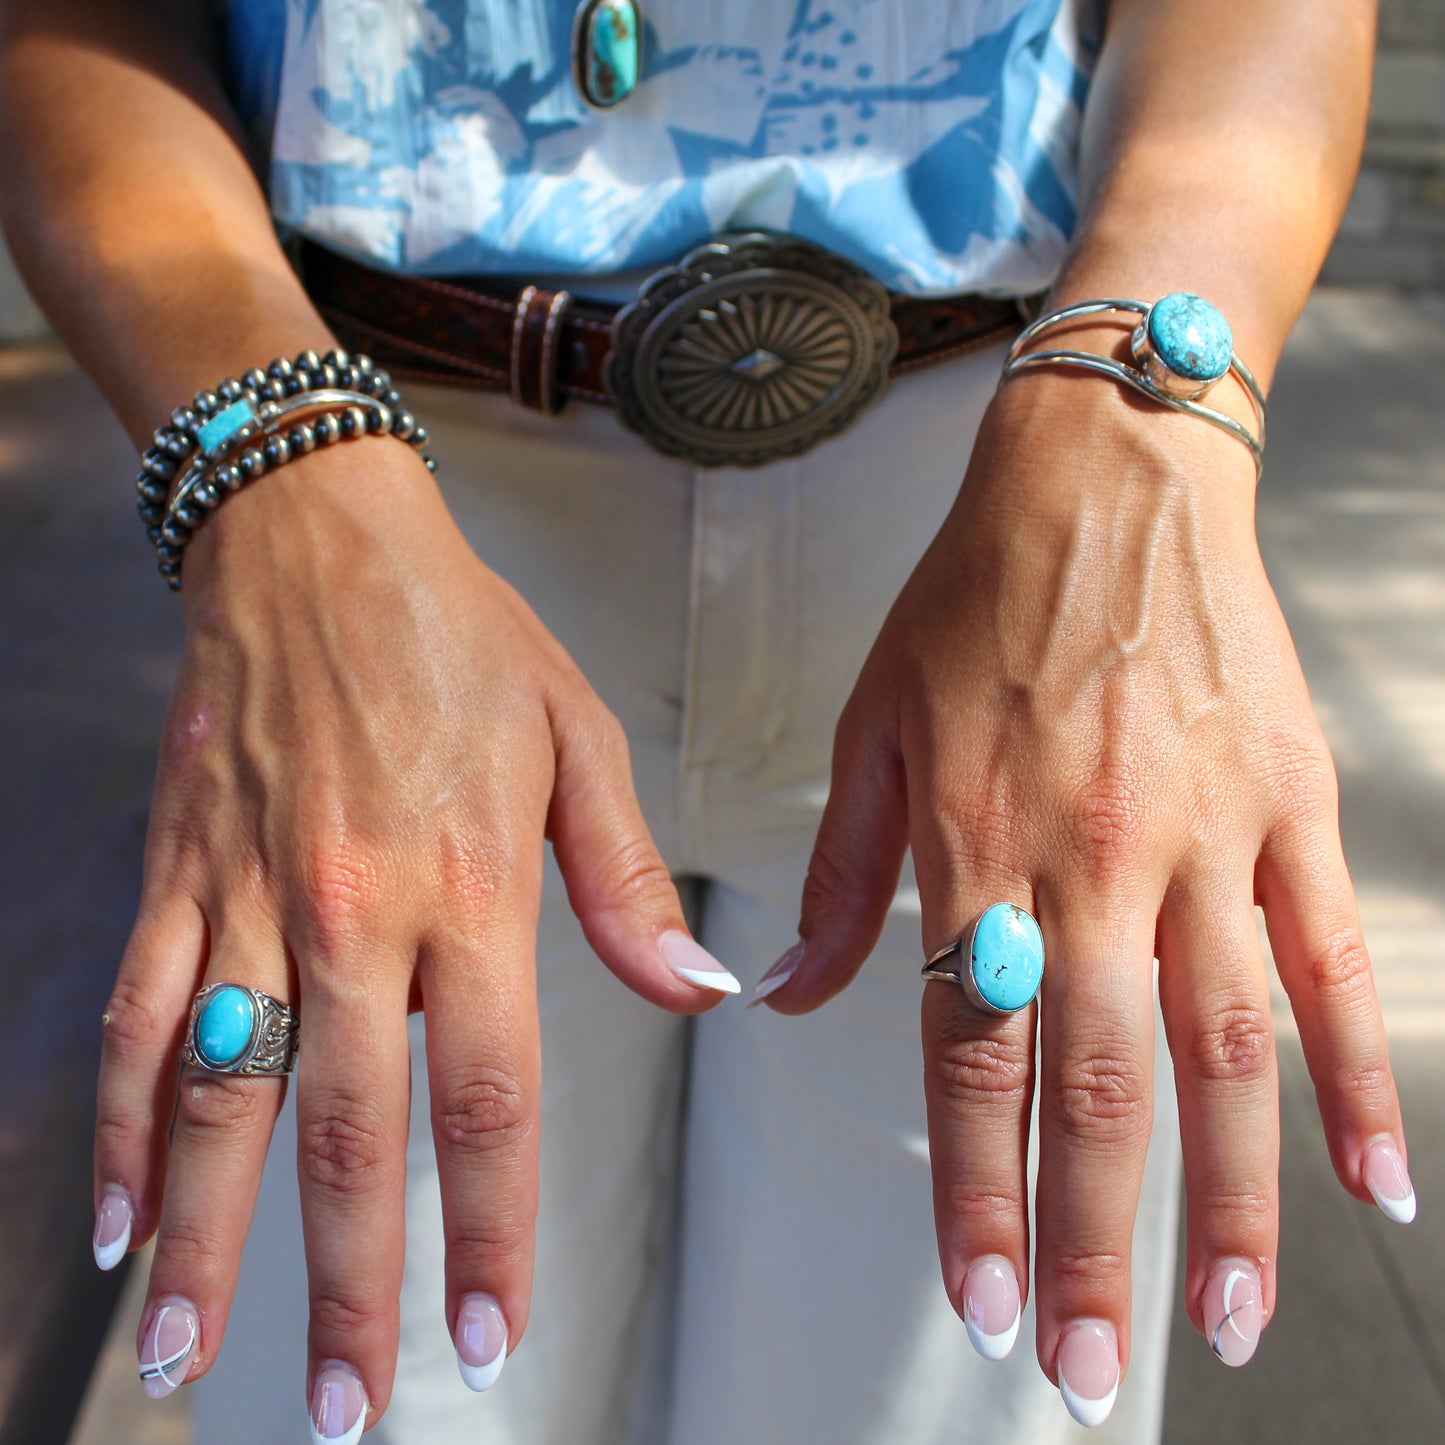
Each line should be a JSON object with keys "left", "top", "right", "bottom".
{"left": 136, "top": 350, "right": 436, "bottom": 591}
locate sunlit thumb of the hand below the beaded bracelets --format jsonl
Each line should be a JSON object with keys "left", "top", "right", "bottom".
{"left": 546, "top": 684, "right": 741, "bottom": 1013}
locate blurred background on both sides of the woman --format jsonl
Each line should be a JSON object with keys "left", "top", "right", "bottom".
{"left": 0, "top": 0, "right": 1445, "bottom": 1445}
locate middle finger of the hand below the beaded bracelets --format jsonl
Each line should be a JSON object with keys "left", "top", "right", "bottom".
{"left": 296, "top": 942, "right": 410, "bottom": 1439}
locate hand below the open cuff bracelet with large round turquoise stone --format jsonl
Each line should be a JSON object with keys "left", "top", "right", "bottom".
{"left": 767, "top": 374, "right": 1413, "bottom": 1423}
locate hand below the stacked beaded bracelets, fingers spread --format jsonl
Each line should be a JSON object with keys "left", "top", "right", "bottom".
{"left": 95, "top": 438, "right": 737, "bottom": 1438}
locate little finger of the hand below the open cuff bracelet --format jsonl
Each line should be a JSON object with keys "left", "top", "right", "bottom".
{"left": 1256, "top": 803, "right": 1415, "bottom": 1224}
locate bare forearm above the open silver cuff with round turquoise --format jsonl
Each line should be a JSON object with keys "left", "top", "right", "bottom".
{"left": 1052, "top": 0, "right": 1374, "bottom": 383}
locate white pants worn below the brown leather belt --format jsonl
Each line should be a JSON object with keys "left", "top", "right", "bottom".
{"left": 195, "top": 335, "right": 1179, "bottom": 1445}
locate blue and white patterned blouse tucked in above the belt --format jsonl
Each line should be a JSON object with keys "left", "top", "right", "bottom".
{"left": 228, "top": 0, "right": 1101, "bottom": 295}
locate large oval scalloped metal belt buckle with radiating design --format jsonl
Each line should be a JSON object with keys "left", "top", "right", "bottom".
{"left": 603, "top": 231, "right": 899, "bottom": 467}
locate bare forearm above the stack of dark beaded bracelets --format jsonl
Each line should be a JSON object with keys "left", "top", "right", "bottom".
{"left": 0, "top": 0, "right": 329, "bottom": 442}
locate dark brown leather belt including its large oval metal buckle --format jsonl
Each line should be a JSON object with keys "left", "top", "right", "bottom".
{"left": 293, "top": 233, "right": 1033, "bottom": 465}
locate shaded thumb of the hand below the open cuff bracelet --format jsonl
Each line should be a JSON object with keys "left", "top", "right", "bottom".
{"left": 753, "top": 694, "right": 907, "bottom": 1014}
